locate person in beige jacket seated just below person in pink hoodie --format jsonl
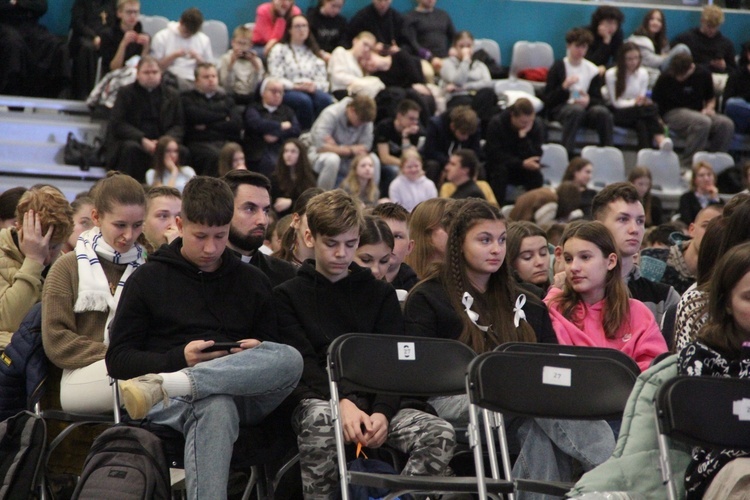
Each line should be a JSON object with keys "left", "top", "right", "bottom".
{"left": 217, "top": 25, "right": 265, "bottom": 104}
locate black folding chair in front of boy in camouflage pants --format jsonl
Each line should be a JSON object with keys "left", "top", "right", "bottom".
{"left": 328, "top": 333, "right": 513, "bottom": 500}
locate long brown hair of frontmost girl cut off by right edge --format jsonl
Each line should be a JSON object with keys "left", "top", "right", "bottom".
{"left": 697, "top": 243, "right": 750, "bottom": 359}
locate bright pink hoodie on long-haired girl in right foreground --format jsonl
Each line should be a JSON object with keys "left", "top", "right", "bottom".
{"left": 544, "top": 288, "right": 667, "bottom": 371}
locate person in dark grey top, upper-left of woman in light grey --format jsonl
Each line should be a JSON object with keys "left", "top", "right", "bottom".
{"left": 404, "top": 0, "right": 456, "bottom": 69}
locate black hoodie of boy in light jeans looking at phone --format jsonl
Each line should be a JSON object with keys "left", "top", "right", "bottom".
{"left": 106, "top": 238, "right": 276, "bottom": 379}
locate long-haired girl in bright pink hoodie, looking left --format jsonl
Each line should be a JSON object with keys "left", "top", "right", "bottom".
{"left": 544, "top": 221, "right": 667, "bottom": 370}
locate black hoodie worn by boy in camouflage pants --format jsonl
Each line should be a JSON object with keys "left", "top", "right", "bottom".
{"left": 274, "top": 260, "right": 404, "bottom": 420}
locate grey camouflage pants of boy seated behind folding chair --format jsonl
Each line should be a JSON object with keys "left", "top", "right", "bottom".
{"left": 292, "top": 399, "right": 456, "bottom": 500}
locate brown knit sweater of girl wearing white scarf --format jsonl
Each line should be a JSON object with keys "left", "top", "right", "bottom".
{"left": 42, "top": 252, "right": 132, "bottom": 370}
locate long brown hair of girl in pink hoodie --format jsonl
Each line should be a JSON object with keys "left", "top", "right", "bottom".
{"left": 553, "top": 221, "right": 630, "bottom": 339}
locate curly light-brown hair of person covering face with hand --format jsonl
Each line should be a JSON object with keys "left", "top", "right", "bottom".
{"left": 16, "top": 186, "right": 73, "bottom": 244}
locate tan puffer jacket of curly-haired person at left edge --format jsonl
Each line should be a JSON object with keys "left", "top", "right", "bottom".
{"left": 0, "top": 228, "right": 44, "bottom": 349}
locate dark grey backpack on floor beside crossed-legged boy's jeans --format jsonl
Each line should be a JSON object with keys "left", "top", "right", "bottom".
{"left": 72, "top": 426, "right": 171, "bottom": 500}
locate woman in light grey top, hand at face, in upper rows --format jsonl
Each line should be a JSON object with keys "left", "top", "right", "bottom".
{"left": 440, "top": 31, "right": 494, "bottom": 109}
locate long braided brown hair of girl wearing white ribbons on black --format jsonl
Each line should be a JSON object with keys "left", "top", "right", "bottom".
{"left": 439, "top": 199, "right": 536, "bottom": 353}
